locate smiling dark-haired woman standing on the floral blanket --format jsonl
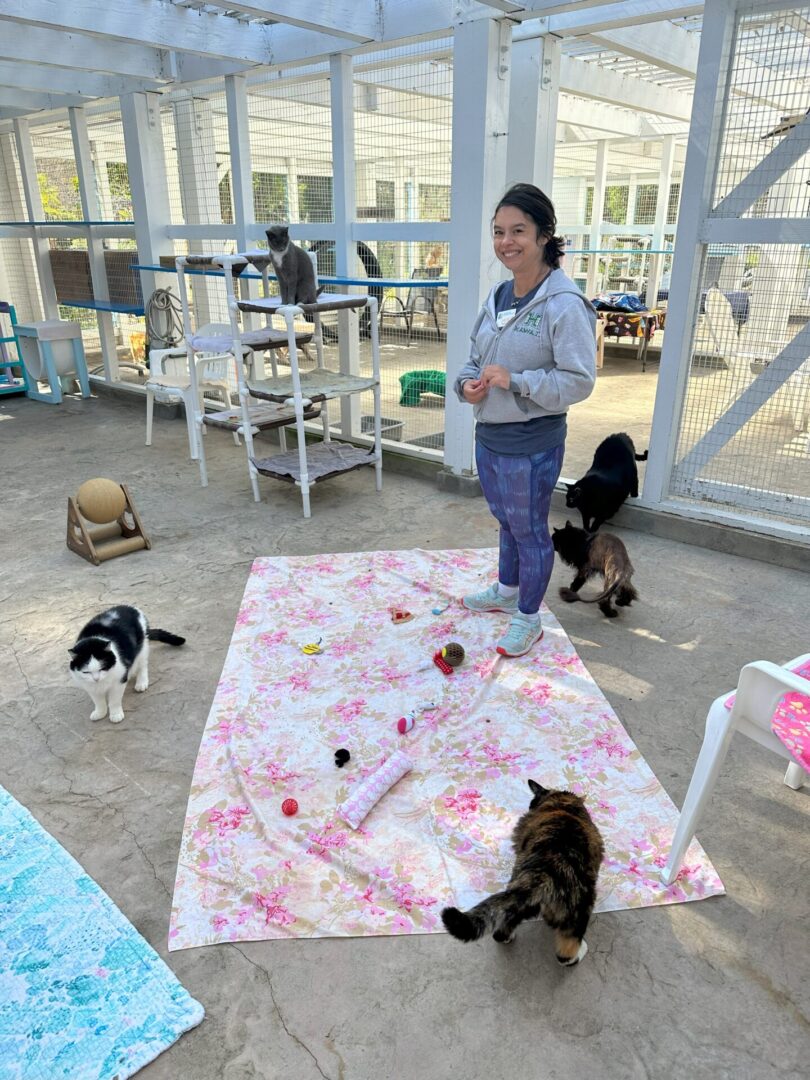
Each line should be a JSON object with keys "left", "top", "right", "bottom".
{"left": 455, "top": 184, "right": 596, "bottom": 657}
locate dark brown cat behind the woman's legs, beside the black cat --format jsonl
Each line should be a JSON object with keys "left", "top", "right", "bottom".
{"left": 551, "top": 522, "right": 638, "bottom": 619}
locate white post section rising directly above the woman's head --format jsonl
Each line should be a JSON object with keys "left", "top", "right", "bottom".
{"left": 507, "top": 27, "right": 561, "bottom": 197}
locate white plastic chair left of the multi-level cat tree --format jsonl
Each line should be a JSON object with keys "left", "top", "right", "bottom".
{"left": 145, "top": 346, "right": 233, "bottom": 461}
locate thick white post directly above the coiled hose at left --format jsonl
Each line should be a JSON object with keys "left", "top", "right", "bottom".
{"left": 121, "top": 94, "right": 174, "bottom": 328}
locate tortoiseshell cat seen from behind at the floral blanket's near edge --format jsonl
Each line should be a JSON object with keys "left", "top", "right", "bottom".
{"left": 442, "top": 780, "right": 605, "bottom": 967}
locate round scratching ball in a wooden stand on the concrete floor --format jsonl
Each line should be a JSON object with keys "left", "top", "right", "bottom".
{"left": 67, "top": 478, "right": 152, "bottom": 566}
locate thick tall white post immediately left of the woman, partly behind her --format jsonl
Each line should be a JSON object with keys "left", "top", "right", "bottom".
{"left": 444, "top": 18, "right": 512, "bottom": 475}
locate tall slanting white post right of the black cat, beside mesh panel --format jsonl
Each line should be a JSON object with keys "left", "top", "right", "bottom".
{"left": 642, "top": 0, "right": 735, "bottom": 504}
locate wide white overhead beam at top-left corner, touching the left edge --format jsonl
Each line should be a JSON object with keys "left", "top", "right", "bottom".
{"left": 0, "top": 22, "right": 174, "bottom": 82}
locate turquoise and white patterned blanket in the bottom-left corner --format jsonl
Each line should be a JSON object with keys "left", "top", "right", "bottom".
{"left": 0, "top": 787, "right": 203, "bottom": 1080}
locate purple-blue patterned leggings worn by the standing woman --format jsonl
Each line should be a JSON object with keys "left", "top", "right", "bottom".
{"left": 475, "top": 443, "right": 565, "bottom": 615}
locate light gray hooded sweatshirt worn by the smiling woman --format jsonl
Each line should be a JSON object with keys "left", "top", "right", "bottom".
{"left": 454, "top": 269, "right": 596, "bottom": 423}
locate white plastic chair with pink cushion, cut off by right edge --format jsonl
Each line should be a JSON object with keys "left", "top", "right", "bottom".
{"left": 663, "top": 652, "right": 810, "bottom": 885}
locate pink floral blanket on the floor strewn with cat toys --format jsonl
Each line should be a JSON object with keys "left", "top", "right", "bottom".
{"left": 170, "top": 550, "right": 723, "bottom": 949}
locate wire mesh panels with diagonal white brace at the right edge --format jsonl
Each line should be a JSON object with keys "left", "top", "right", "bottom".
{"left": 671, "top": 0, "right": 810, "bottom": 522}
